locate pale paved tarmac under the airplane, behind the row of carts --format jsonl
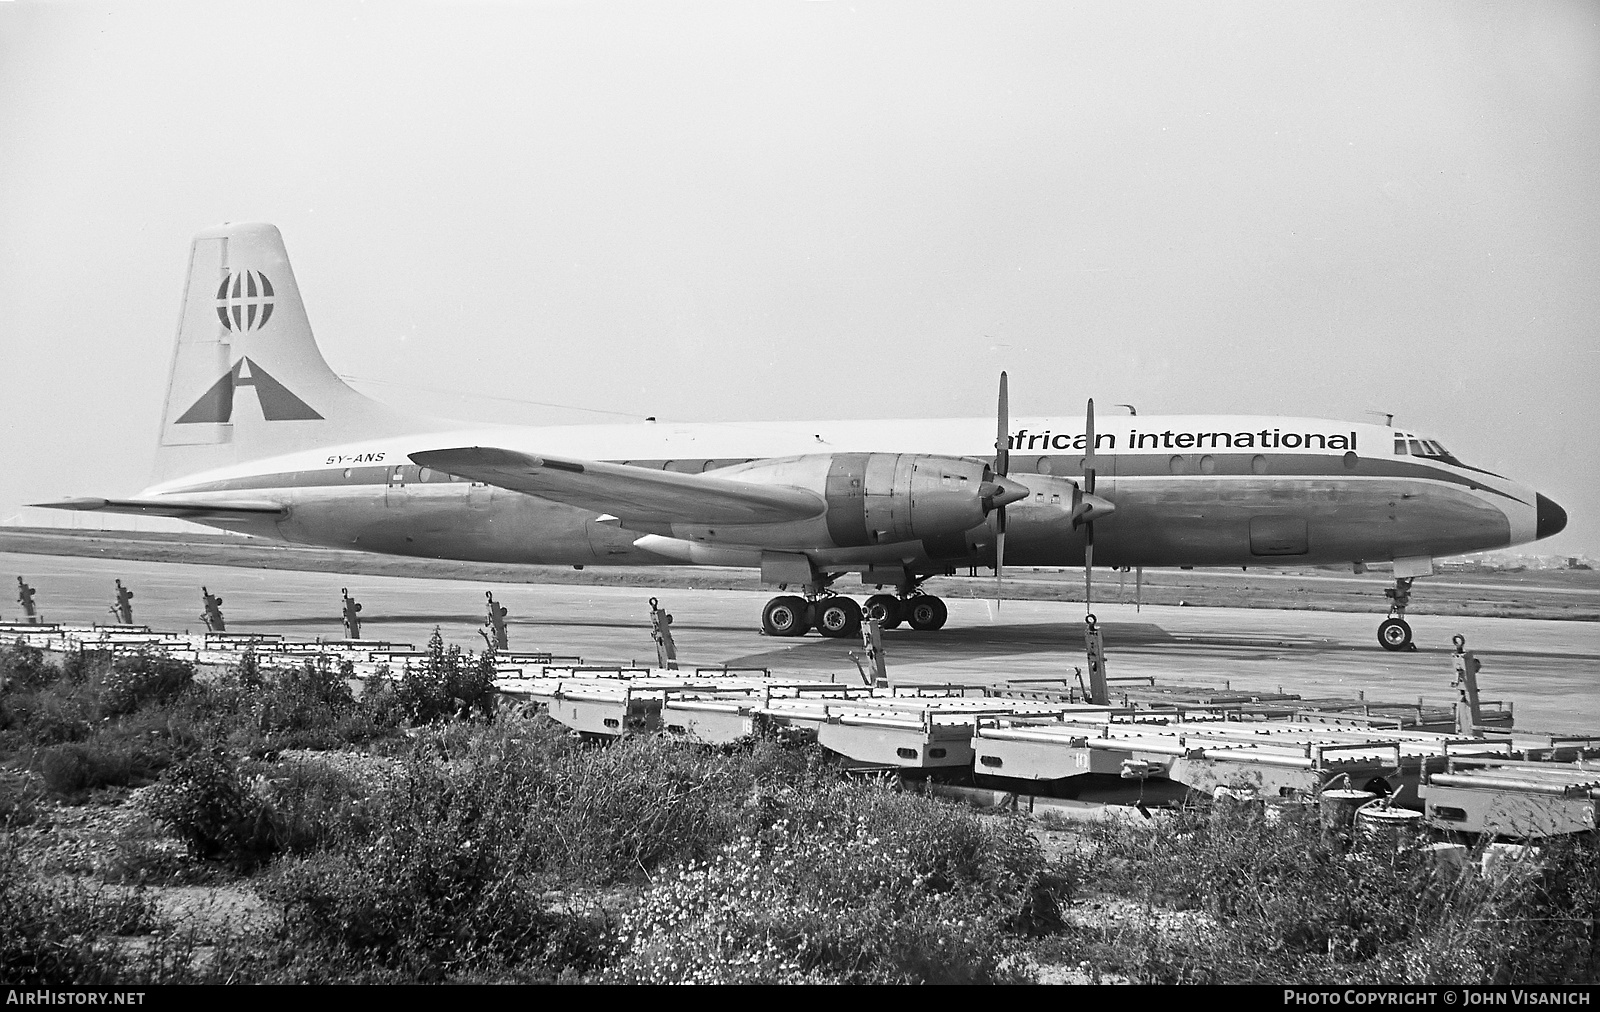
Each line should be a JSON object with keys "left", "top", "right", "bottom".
{"left": 0, "top": 552, "right": 1600, "bottom": 733}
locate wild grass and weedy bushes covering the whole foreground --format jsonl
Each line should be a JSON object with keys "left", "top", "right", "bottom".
{"left": 0, "top": 637, "right": 1600, "bottom": 983}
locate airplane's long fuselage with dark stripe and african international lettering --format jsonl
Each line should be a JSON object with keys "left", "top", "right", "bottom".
{"left": 147, "top": 416, "right": 1538, "bottom": 572}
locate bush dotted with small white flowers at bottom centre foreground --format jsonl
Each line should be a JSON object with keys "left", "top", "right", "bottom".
{"left": 603, "top": 783, "right": 1043, "bottom": 983}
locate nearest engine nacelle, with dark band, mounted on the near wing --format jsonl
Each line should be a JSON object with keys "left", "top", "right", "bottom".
{"left": 707, "top": 453, "right": 1027, "bottom": 549}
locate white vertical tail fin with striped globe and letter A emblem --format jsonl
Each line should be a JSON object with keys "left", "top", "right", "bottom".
{"left": 155, "top": 223, "right": 430, "bottom": 482}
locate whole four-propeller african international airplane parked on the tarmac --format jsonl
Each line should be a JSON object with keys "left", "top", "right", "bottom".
{"left": 38, "top": 223, "right": 1566, "bottom": 650}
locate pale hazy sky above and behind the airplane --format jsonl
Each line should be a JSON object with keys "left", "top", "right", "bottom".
{"left": 0, "top": 0, "right": 1600, "bottom": 554}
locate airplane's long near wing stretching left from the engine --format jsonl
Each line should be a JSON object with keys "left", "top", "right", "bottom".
{"left": 411, "top": 447, "right": 827, "bottom": 524}
